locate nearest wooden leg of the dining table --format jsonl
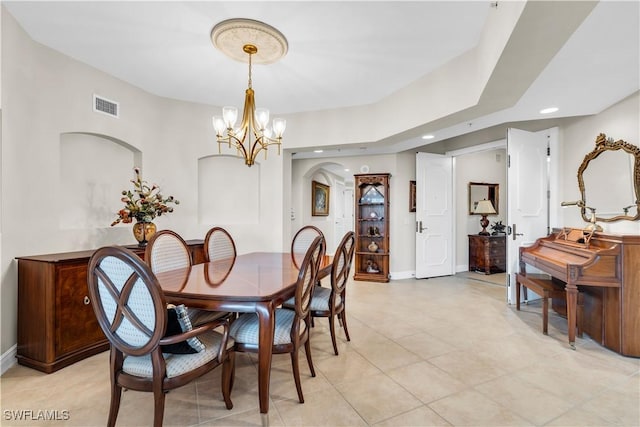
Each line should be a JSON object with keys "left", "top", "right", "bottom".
{"left": 256, "top": 302, "right": 275, "bottom": 423}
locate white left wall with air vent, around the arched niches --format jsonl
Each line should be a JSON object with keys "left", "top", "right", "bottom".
{"left": 0, "top": 11, "right": 284, "bottom": 354}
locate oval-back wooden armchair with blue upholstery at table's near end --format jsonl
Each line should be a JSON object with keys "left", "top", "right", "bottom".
{"left": 87, "top": 246, "right": 235, "bottom": 426}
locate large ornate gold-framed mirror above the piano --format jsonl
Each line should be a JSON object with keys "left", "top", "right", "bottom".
{"left": 578, "top": 133, "right": 640, "bottom": 222}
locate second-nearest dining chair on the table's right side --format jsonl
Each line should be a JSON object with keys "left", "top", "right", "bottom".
{"left": 282, "top": 231, "right": 355, "bottom": 356}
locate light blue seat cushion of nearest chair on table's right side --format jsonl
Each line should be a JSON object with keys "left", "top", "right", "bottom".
{"left": 229, "top": 308, "right": 306, "bottom": 345}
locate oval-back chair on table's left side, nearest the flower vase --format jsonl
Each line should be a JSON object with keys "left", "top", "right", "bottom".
{"left": 144, "top": 230, "right": 229, "bottom": 326}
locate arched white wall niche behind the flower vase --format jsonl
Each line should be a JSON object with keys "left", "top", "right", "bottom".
{"left": 58, "top": 132, "right": 142, "bottom": 230}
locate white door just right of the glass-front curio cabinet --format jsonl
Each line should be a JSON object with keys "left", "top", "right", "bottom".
{"left": 416, "top": 153, "right": 455, "bottom": 279}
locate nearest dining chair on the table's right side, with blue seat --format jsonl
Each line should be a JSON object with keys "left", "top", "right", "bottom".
{"left": 229, "top": 236, "right": 325, "bottom": 403}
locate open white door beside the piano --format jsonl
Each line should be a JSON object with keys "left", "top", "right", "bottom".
{"left": 507, "top": 129, "right": 556, "bottom": 304}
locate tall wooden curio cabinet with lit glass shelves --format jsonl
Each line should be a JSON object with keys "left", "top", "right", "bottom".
{"left": 353, "top": 173, "right": 391, "bottom": 282}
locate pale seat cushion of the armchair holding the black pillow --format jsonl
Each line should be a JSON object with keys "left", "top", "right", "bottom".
{"left": 122, "top": 331, "right": 234, "bottom": 378}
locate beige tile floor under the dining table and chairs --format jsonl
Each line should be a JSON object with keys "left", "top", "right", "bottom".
{"left": 0, "top": 274, "right": 640, "bottom": 426}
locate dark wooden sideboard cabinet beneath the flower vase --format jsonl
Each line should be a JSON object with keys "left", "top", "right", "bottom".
{"left": 17, "top": 240, "right": 204, "bottom": 373}
